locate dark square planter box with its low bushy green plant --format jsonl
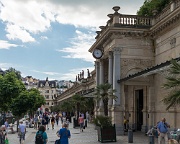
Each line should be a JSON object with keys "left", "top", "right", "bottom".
{"left": 93, "top": 115, "right": 116, "bottom": 143}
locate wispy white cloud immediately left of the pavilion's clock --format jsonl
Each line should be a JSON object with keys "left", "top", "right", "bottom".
{"left": 57, "top": 30, "right": 95, "bottom": 63}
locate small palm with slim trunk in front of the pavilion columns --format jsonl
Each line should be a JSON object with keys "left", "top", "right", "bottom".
{"left": 95, "top": 83, "right": 116, "bottom": 116}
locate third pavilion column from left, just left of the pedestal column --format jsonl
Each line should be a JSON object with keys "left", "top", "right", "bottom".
{"left": 108, "top": 51, "right": 113, "bottom": 116}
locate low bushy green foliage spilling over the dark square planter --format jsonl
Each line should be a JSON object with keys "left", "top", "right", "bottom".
{"left": 93, "top": 115, "right": 112, "bottom": 128}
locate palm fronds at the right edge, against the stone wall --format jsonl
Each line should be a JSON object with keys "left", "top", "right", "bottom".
{"left": 162, "top": 60, "right": 180, "bottom": 110}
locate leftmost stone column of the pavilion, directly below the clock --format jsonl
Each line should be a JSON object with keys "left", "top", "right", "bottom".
{"left": 94, "top": 61, "right": 100, "bottom": 116}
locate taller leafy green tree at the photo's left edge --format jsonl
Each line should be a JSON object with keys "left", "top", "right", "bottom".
{"left": 0, "top": 72, "right": 26, "bottom": 111}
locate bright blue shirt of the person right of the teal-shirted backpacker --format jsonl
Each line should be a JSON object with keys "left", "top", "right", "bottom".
{"left": 59, "top": 128, "right": 71, "bottom": 144}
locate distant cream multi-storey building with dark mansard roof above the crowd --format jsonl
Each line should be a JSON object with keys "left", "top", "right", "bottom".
{"left": 37, "top": 78, "right": 58, "bottom": 112}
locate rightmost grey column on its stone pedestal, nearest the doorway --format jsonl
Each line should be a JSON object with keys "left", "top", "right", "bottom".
{"left": 112, "top": 47, "right": 124, "bottom": 135}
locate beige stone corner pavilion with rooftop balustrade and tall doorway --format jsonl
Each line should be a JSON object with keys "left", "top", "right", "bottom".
{"left": 89, "top": 0, "right": 180, "bottom": 135}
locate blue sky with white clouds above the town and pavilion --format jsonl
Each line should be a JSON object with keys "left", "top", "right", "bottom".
{"left": 0, "top": 0, "right": 144, "bottom": 81}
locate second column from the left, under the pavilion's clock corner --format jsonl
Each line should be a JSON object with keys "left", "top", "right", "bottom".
{"left": 98, "top": 59, "right": 104, "bottom": 115}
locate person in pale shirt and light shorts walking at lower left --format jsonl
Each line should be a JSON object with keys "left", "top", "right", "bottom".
{"left": 18, "top": 121, "right": 26, "bottom": 144}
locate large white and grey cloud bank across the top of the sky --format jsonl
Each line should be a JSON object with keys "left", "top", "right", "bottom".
{"left": 0, "top": 0, "right": 144, "bottom": 42}
